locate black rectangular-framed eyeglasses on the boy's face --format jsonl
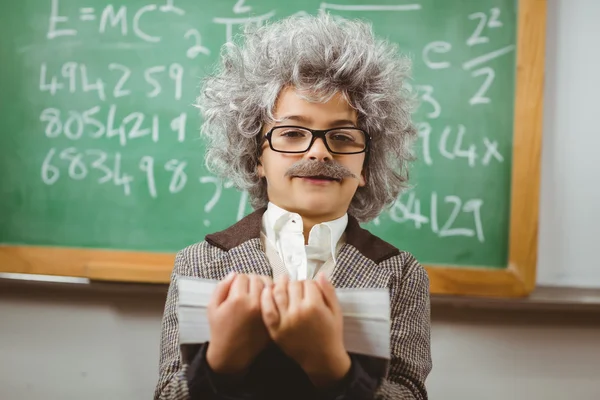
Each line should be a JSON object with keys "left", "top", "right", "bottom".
{"left": 265, "top": 125, "right": 371, "bottom": 154}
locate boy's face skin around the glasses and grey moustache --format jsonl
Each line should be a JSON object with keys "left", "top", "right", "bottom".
{"left": 258, "top": 88, "right": 365, "bottom": 221}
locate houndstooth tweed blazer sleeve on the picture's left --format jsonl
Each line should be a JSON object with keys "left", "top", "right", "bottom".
{"left": 154, "top": 250, "right": 250, "bottom": 400}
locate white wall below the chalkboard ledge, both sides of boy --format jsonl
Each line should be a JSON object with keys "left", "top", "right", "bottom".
{"left": 0, "top": 287, "right": 600, "bottom": 400}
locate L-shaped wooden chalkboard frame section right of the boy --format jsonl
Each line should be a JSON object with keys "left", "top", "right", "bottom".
{"left": 427, "top": 0, "right": 546, "bottom": 297}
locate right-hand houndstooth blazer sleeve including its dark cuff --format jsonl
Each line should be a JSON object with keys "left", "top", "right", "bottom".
{"left": 310, "top": 253, "right": 431, "bottom": 400}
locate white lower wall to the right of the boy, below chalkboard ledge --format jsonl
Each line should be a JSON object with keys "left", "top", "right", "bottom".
{"left": 428, "top": 309, "right": 600, "bottom": 400}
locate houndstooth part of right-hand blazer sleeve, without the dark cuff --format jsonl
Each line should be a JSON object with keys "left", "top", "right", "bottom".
{"left": 375, "top": 253, "right": 432, "bottom": 400}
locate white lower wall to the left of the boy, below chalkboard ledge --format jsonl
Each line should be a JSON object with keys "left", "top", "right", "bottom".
{"left": 0, "top": 288, "right": 164, "bottom": 400}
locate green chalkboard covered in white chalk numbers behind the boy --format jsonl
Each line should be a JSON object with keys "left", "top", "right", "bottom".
{"left": 0, "top": 0, "right": 517, "bottom": 269}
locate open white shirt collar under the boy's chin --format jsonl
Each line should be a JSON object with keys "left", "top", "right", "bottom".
{"left": 263, "top": 202, "right": 348, "bottom": 262}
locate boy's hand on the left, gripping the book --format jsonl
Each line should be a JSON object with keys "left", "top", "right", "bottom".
{"left": 206, "top": 273, "right": 271, "bottom": 374}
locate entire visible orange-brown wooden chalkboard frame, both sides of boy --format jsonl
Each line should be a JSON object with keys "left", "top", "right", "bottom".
{"left": 0, "top": 0, "right": 546, "bottom": 297}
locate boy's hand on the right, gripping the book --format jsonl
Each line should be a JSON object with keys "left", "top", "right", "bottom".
{"left": 261, "top": 274, "right": 351, "bottom": 387}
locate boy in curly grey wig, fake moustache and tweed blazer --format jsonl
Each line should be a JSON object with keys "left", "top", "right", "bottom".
{"left": 155, "top": 14, "right": 431, "bottom": 400}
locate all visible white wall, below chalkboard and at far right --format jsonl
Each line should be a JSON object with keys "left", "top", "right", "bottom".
{"left": 0, "top": 0, "right": 600, "bottom": 400}
